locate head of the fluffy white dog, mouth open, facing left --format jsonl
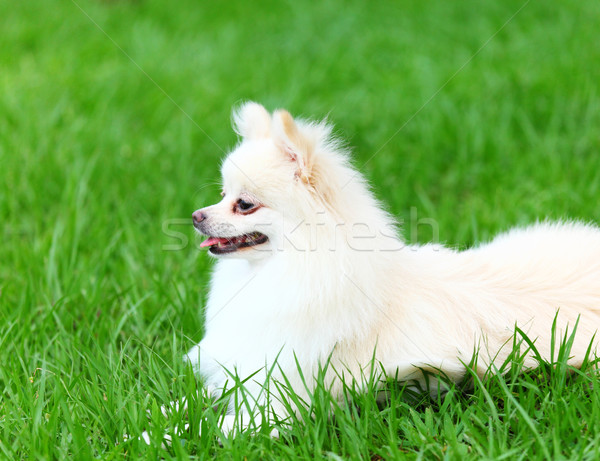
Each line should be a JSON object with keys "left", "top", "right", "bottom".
{"left": 193, "top": 102, "right": 346, "bottom": 259}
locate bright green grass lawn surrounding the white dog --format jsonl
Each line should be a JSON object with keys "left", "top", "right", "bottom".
{"left": 0, "top": 0, "right": 600, "bottom": 459}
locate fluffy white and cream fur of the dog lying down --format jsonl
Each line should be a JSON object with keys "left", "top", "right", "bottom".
{"left": 187, "top": 103, "right": 600, "bottom": 434}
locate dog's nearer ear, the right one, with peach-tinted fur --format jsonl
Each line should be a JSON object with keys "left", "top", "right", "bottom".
{"left": 271, "top": 109, "right": 314, "bottom": 184}
